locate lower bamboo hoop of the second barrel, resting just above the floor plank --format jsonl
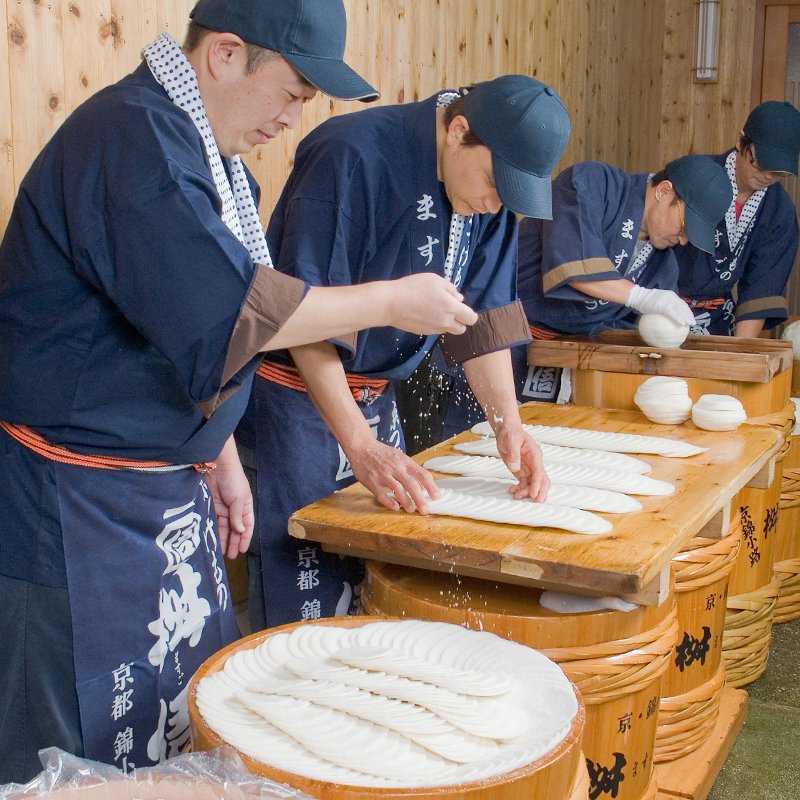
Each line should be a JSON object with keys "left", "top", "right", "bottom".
{"left": 653, "top": 664, "right": 725, "bottom": 763}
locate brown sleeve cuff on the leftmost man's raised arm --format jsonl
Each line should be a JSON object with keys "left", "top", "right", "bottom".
{"left": 198, "top": 264, "right": 308, "bottom": 418}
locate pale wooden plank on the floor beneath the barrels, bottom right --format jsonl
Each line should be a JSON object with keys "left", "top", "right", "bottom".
{"left": 655, "top": 689, "right": 748, "bottom": 800}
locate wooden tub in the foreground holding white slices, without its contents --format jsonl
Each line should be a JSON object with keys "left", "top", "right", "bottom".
{"left": 189, "top": 616, "right": 586, "bottom": 800}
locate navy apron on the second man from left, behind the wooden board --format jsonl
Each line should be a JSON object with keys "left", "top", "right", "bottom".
{"left": 253, "top": 377, "right": 405, "bottom": 627}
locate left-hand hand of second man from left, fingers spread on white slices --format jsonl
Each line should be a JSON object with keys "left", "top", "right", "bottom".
{"left": 347, "top": 438, "right": 439, "bottom": 514}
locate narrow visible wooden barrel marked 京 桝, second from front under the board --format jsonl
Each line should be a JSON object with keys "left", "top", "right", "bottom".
{"left": 655, "top": 517, "right": 741, "bottom": 763}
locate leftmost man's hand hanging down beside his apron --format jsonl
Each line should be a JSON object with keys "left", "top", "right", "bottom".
{"left": 205, "top": 438, "right": 255, "bottom": 558}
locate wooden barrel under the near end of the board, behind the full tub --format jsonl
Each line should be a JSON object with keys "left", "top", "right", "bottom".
{"left": 361, "top": 561, "right": 677, "bottom": 800}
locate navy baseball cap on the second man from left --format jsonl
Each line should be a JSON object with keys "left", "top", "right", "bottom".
{"left": 464, "top": 75, "right": 570, "bottom": 219}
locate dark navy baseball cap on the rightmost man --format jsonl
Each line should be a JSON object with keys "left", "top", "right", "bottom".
{"left": 744, "top": 100, "right": 800, "bottom": 175}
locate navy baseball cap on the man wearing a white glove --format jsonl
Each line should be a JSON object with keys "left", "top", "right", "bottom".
{"left": 664, "top": 155, "right": 733, "bottom": 255}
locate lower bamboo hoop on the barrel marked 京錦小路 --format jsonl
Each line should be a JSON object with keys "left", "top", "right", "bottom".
{"left": 722, "top": 578, "right": 780, "bottom": 688}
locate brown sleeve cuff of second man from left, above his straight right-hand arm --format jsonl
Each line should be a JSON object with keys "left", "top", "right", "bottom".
{"left": 439, "top": 300, "right": 531, "bottom": 366}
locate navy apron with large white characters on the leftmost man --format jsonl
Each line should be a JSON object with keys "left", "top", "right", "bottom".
{"left": 53, "top": 463, "right": 240, "bottom": 771}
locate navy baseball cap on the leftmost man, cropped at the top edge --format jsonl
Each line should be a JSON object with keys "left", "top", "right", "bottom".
{"left": 189, "top": 0, "right": 380, "bottom": 102}
